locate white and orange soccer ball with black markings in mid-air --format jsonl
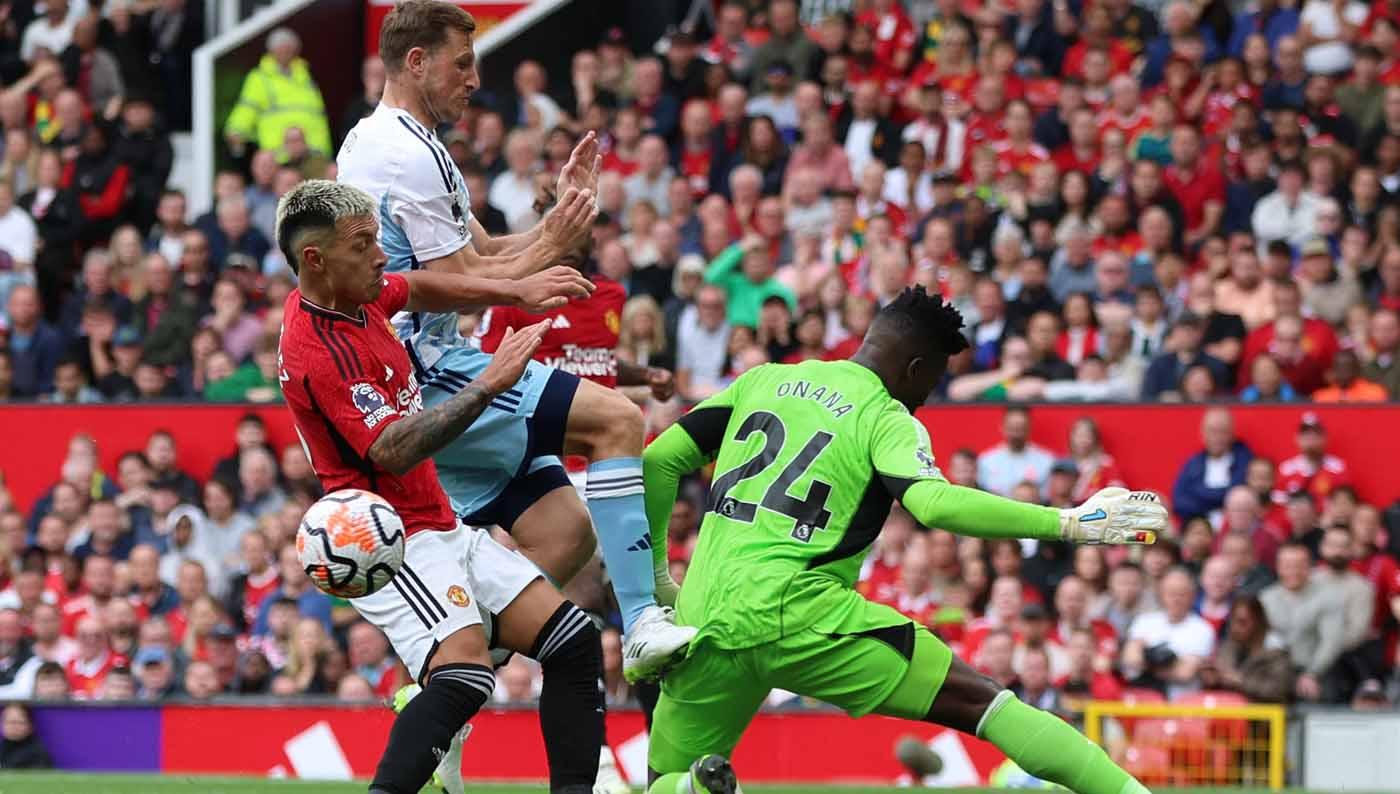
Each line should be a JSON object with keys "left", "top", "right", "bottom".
{"left": 297, "top": 489, "right": 403, "bottom": 598}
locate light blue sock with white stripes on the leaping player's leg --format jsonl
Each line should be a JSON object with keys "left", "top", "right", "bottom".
{"left": 584, "top": 458, "right": 657, "bottom": 632}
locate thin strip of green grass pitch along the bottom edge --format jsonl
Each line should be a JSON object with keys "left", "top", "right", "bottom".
{"left": 0, "top": 770, "right": 1344, "bottom": 794}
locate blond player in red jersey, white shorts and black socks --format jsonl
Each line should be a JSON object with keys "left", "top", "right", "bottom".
{"left": 277, "top": 179, "right": 616, "bottom": 794}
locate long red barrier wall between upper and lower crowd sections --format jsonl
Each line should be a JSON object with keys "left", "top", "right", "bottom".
{"left": 0, "top": 405, "right": 1400, "bottom": 510}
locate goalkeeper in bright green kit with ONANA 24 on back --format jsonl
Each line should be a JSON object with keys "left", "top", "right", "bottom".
{"left": 643, "top": 287, "right": 1166, "bottom": 794}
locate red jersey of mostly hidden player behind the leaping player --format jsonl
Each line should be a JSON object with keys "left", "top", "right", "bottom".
{"left": 476, "top": 276, "right": 627, "bottom": 388}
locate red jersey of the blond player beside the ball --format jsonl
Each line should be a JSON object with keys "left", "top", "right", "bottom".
{"left": 277, "top": 274, "right": 456, "bottom": 535}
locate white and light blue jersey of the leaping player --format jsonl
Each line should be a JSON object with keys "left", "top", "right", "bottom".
{"left": 336, "top": 102, "right": 472, "bottom": 370}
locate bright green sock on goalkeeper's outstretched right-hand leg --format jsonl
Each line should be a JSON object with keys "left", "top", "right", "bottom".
{"left": 977, "top": 690, "right": 1149, "bottom": 794}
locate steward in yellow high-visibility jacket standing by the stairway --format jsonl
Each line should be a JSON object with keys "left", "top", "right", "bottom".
{"left": 224, "top": 28, "right": 333, "bottom": 161}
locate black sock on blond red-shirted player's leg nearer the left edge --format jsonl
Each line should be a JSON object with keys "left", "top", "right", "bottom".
{"left": 370, "top": 664, "right": 495, "bottom": 794}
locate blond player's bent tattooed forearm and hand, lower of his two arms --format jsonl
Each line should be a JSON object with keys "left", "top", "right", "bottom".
{"left": 370, "top": 321, "right": 549, "bottom": 475}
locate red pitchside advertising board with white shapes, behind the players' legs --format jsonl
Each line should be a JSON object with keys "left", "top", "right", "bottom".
{"left": 161, "top": 706, "right": 1005, "bottom": 786}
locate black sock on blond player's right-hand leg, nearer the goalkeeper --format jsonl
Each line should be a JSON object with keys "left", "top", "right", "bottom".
{"left": 529, "top": 601, "right": 603, "bottom": 794}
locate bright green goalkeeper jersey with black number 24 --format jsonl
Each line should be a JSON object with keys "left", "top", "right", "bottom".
{"left": 644, "top": 361, "right": 1060, "bottom": 648}
